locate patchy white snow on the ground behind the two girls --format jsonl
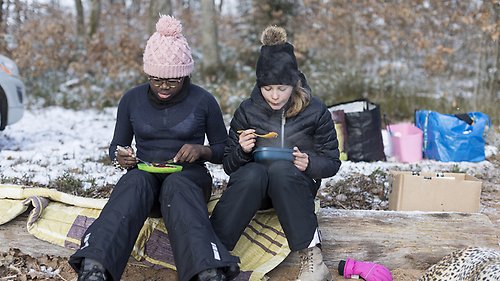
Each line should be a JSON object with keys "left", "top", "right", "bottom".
{"left": 0, "top": 107, "right": 497, "bottom": 199}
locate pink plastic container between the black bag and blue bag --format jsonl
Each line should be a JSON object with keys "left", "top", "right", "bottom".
{"left": 387, "top": 123, "right": 423, "bottom": 163}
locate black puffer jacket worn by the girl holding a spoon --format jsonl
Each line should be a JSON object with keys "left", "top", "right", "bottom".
{"left": 223, "top": 76, "right": 341, "bottom": 179}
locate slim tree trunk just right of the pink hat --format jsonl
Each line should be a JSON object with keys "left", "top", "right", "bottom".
{"left": 201, "top": 0, "right": 220, "bottom": 81}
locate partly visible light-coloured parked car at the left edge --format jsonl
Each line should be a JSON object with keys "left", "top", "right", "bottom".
{"left": 0, "top": 55, "right": 26, "bottom": 131}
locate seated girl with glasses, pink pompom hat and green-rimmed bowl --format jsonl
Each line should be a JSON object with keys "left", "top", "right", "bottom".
{"left": 69, "top": 15, "right": 239, "bottom": 281}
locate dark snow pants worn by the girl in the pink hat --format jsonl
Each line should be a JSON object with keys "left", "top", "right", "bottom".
{"left": 69, "top": 164, "right": 239, "bottom": 281}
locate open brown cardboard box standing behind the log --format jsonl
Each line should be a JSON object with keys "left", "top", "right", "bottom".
{"left": 389, "top": 171, "right": 482, "bottom": 213}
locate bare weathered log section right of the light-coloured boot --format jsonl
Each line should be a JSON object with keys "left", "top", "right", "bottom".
{"left": 312, "top": 209, "right": 499, "bottom": 269}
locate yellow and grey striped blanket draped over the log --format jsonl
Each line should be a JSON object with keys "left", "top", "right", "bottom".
{"left": 0, "top": 185, "right": 290, "bottom": 281}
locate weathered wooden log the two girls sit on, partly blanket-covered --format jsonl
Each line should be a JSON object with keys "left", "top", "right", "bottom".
{"left": 0, "top": 209, "right": 499, "bottom": 281}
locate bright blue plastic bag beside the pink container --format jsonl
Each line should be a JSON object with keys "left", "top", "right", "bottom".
{"left": 415, "top": 110, "right": 491, "bottom": 162}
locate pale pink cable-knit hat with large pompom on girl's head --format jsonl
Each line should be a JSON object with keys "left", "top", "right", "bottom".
{"left": 143, "top": 15, "right": 194, "bottom": 78}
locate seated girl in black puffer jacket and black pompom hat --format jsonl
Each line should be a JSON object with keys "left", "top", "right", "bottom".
{"left": 211, "top": 26, "right": 341, "bottom": 281}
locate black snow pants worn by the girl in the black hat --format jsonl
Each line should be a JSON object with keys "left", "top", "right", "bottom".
{"left": 210, "top": 161, "right": 320, "bottom": 251}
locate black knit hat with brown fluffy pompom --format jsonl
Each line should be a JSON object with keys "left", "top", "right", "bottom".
{"left": 255, "top": 26, "right": 299, "bottom": 87}
